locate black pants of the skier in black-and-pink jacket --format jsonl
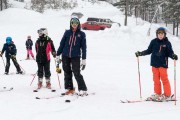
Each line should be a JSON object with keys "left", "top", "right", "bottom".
{"left": 37, "top": 61, "right": 51, "bottom": 79}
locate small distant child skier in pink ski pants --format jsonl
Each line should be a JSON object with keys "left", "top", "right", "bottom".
{"left": 25, "top": 35, "right": 34, "bottom": 60}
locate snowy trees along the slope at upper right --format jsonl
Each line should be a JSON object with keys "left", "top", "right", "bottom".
{"left": 100, "top": 0, "right": 180, "bottom": 36}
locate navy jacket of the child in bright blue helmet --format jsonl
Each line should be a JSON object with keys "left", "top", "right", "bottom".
{"left": 2, "top": 42, "right": 17, "bottom": 58}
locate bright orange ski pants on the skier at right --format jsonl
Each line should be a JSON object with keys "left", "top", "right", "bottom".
{"left": 152, "top": 67, "right": 171, "bottom": 96}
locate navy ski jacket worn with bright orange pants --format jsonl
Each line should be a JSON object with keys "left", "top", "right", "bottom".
{"left": 141, "top": 37, "right": 174, "bottom": 68}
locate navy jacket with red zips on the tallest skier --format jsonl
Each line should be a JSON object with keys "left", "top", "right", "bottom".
{"left": 57, "top": 24, "right": 87, "bottom": 59}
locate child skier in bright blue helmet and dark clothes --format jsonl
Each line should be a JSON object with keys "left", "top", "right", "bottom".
{"left": 0, "top": 37, "right": 23, "bottom": 75}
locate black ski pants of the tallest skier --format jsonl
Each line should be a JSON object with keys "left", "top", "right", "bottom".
{"left": 62, "top": 56, "right": 87, "bottom": 91}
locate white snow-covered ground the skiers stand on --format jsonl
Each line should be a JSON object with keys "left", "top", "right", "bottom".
{"left": 0, "top": 2, "right": 180, "bottom": 120}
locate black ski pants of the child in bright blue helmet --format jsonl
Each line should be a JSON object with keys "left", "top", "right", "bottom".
{"left": 5, "top": 57, "right": 21, "bottom": 73}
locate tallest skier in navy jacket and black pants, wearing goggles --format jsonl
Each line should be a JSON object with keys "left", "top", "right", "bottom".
{"left": 56, "top": 18, "right": 87, "bottom": 96}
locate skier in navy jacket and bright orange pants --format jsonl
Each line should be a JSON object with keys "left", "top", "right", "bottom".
{"left": 135, "top": 27, "right": 178, "bottom": 101}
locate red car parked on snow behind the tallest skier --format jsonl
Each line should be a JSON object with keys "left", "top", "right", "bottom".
{"left": 81, "top": 21, "right": 106, "bottom": 30}
